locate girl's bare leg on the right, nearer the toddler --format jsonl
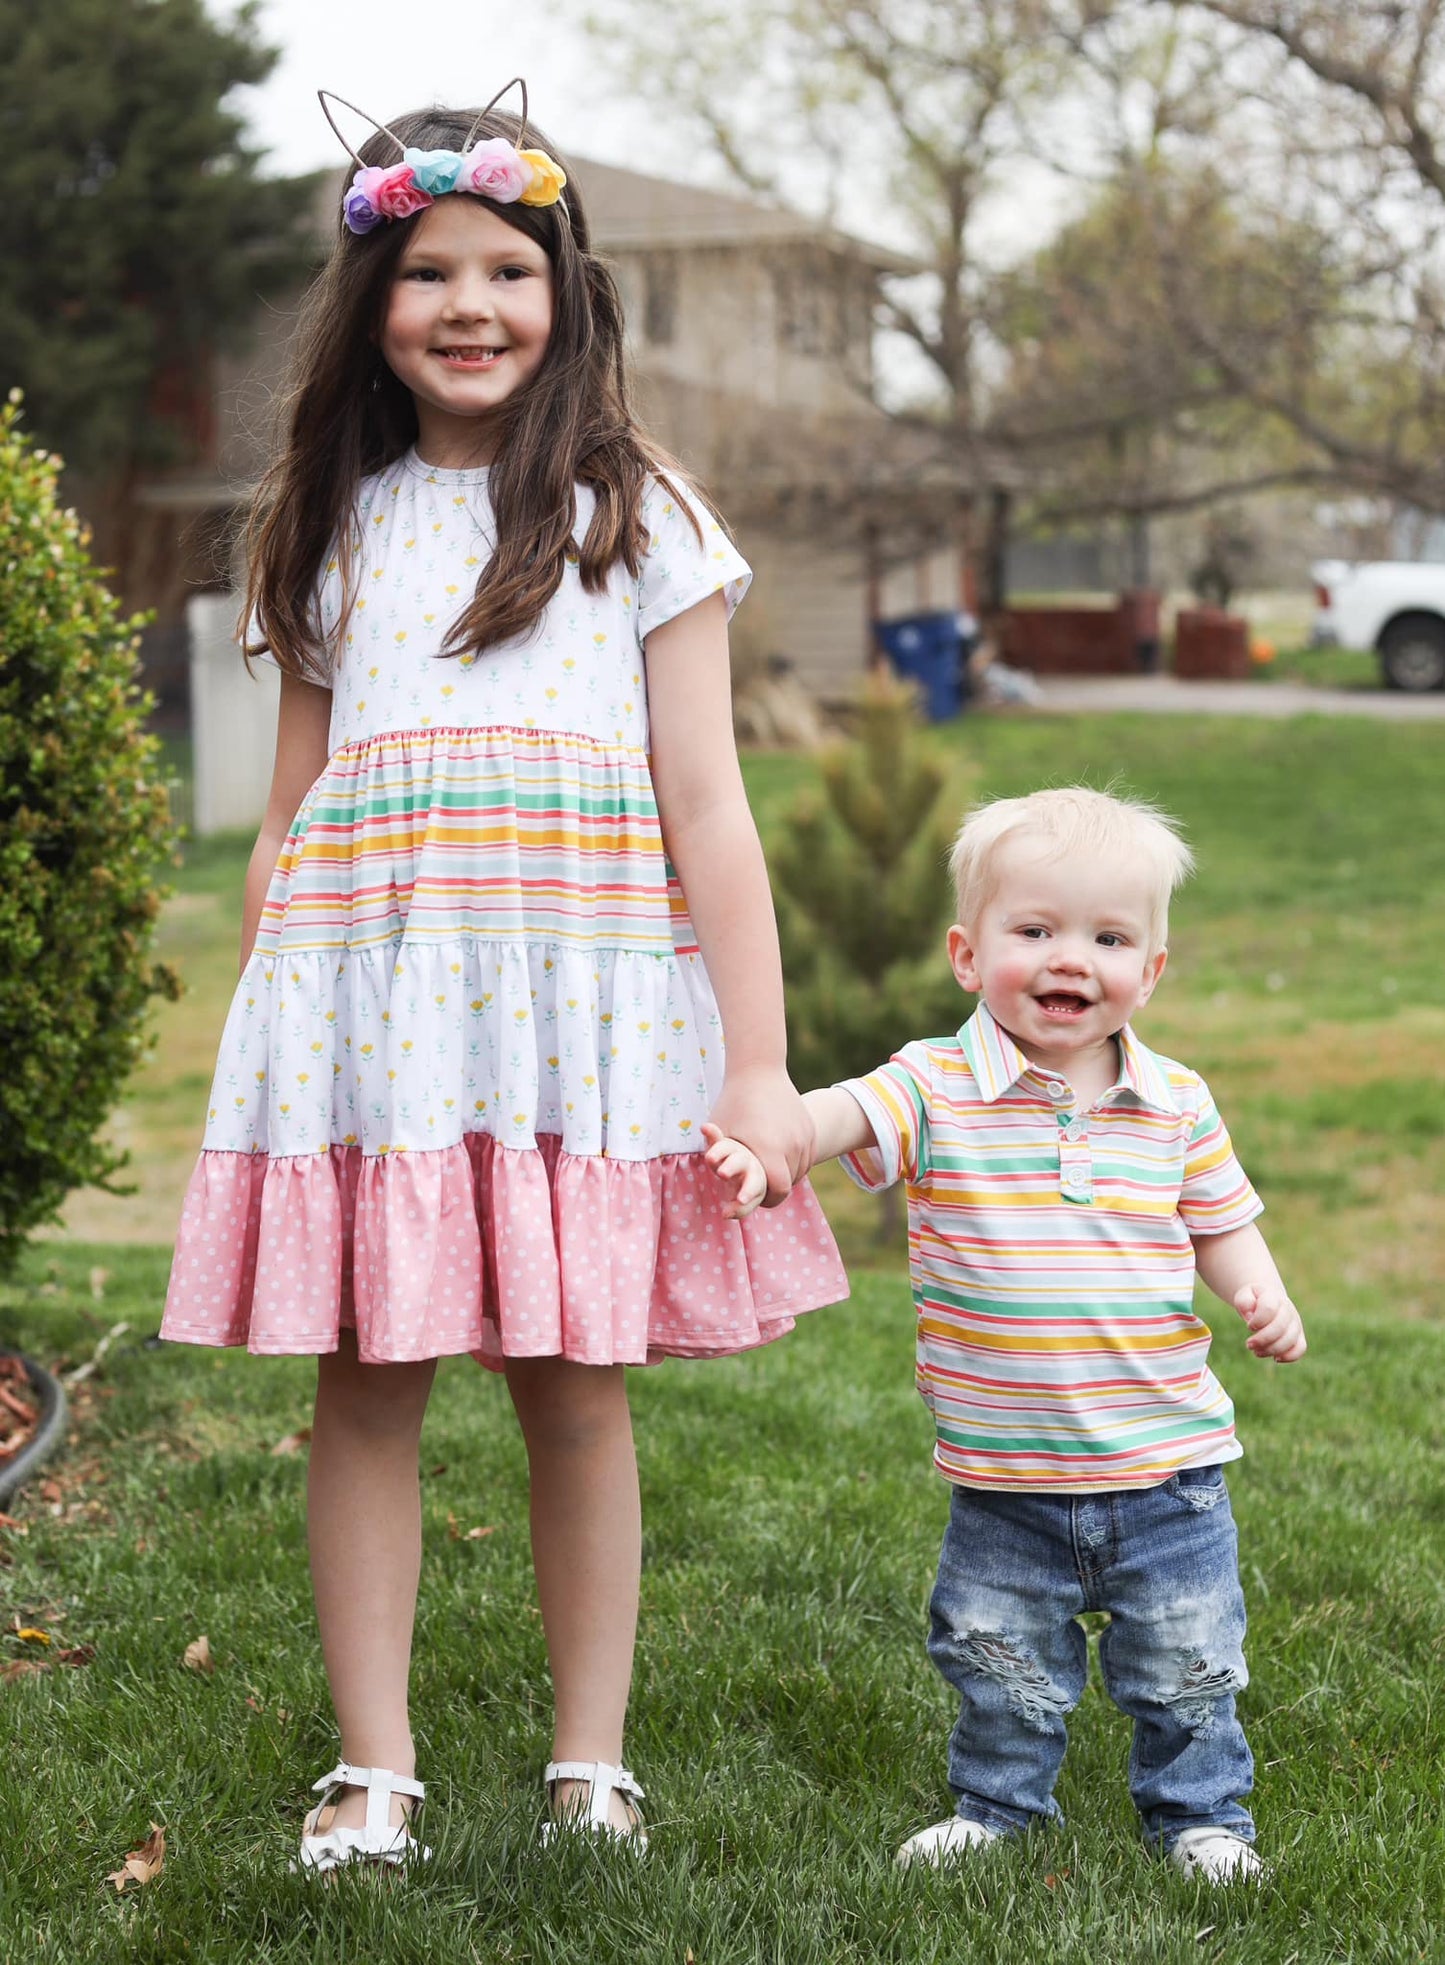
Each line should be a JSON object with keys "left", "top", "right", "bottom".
{"left": 507, "top": 1358, "right": 643, "bottom": 1827}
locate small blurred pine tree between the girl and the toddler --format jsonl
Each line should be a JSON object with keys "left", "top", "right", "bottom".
{"left": 769, "top": 680, "right": 965, "bottom": 1116}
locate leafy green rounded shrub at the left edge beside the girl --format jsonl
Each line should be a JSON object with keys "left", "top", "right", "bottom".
{"left": 0, "top": 391, "right": 177, "bottom": 1273}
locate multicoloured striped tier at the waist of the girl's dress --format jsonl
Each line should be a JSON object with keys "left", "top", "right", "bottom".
{"left": 258, "top": 725, "right": 696, "bottom": 955}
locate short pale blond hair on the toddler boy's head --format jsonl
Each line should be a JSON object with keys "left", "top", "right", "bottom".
{"left": 948, "top": 784, "right": 1193, "bottom": 955}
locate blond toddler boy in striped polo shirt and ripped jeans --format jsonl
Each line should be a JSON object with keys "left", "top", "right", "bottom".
{"left": 706, "top": 788, "right": 1305, "bottom": 1882}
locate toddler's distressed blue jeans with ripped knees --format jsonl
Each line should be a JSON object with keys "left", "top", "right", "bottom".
{"left": 928, "top": 1466, "right": 1254, "bottom": 1847}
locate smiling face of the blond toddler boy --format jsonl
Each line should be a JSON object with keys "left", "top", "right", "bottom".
{"left": 948, "top": 835, "right": 1166, "bottom": 1077}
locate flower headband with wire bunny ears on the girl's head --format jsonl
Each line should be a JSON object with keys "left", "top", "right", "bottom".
{"left": 317, "top": 75, "right": 566, "bottom": 232}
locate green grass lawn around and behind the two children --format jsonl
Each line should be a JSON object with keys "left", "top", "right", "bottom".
{"left": 0, "top": 717, "right": 1445, "bottom": 1965}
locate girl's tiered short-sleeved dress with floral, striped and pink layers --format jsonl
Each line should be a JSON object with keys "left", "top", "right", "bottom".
{"left": 161, "top": 452, "right": 847, "bottom": 1366}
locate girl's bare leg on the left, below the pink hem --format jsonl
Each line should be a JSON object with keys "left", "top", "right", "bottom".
{"left": 307, "top": 1330, "right": 436, "bottom": 1829}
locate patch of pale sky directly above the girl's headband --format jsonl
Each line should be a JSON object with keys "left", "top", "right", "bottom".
{"left": 230, "top": 0, "right": 678, "bottom": 175}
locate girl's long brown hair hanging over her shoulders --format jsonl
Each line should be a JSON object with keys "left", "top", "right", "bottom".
{"left": 246, "top": 108, "right": 686, "bottom": 682}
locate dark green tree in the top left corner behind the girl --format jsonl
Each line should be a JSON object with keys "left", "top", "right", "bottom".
{"left": 0, "top": 0, "right": 315, "bottom": 483}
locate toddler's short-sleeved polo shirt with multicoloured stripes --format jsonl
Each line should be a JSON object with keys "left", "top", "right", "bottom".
{"left": 843, "top": 1004, "right": 1262, "bottom": 1493}
